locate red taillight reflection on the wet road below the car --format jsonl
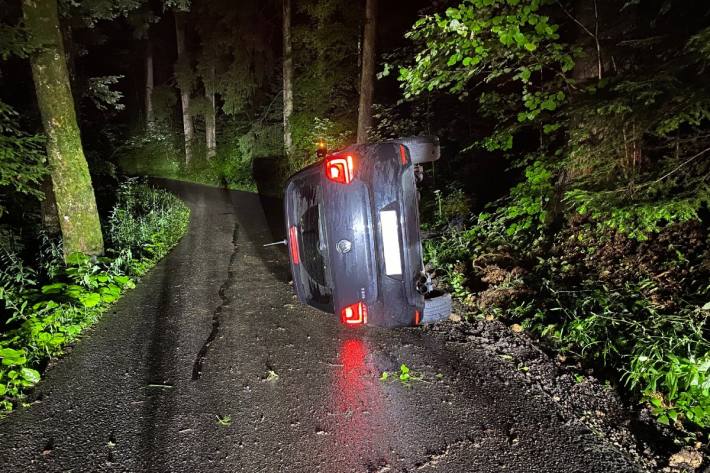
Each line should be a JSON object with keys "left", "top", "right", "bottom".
{"left": 332, "top": 338, "right": 391, "bottom": 471}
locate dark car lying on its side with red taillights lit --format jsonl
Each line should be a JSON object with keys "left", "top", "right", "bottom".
{"left": 285, "top": 137, "right": 451, "bottom": 327}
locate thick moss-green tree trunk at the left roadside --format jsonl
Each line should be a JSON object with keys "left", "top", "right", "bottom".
{"left": 22, "top": 0, "right": 104, "bottom": 257}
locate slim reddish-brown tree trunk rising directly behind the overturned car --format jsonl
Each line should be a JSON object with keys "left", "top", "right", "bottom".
{"left": 357, "top": 0, "right": 377, "bottom": 143}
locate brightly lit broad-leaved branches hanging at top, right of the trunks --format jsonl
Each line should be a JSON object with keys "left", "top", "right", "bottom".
{"left": 399, "top": 0, "right": 574, "bottom": 152}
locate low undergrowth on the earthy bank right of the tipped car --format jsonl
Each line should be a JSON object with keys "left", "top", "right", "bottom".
{"left": 425, "top": 186, "right": 710, "bottom": 428}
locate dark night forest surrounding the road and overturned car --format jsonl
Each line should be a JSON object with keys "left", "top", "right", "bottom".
{"left": 0, "top": 0, "right": 710, "bottom": 466}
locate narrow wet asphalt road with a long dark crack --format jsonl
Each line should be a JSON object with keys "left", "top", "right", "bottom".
{"left": 0, "top": 182, "right": 639, "bottom": 473}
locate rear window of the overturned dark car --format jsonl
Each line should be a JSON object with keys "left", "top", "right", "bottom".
{"left": 290, "top": 171, "right": 333, "bottom": 312}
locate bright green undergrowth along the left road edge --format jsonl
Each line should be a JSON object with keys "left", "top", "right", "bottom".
{"left": 0, "top": 179, "right": 190, "bottom": 411}
